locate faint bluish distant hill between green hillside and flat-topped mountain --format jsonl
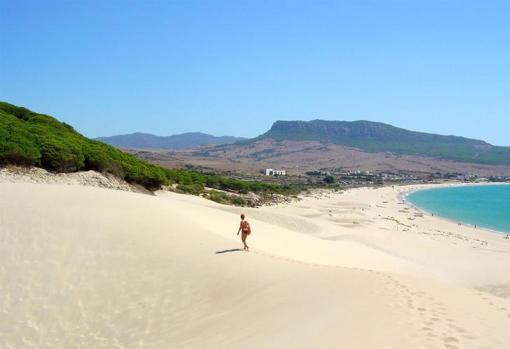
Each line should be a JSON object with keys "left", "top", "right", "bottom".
{"left": 97, "top": 132, "right": 244, "bottom": 149}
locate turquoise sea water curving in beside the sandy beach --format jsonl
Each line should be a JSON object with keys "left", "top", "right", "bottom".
{"left": 407, "top": 185, "right": 510, "bottom": 233}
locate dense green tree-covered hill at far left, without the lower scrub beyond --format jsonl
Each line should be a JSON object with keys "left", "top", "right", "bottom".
{"left": 0, "top": 102, "right": 167, "bottom": 189}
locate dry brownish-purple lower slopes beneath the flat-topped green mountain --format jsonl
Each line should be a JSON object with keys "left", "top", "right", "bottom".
{"left": 145, "top": 139, "right": 510, "bottom": 178}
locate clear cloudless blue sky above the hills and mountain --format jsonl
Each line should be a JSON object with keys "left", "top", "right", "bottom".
{"left": 0, "top": 0, "right": 510, "bottom": 145}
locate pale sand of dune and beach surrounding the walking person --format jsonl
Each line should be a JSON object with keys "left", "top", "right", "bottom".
{"left": 0, "top": 183, "right": 510, "bottom": 348}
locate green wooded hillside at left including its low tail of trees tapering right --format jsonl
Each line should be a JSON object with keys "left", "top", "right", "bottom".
{"left": 0, "top": 102, "right": 293, "bottom": 194}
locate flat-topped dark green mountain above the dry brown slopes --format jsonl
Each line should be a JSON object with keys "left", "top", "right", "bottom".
{"left": 255, "top": 120, "right": 510, "bottom": 165}
